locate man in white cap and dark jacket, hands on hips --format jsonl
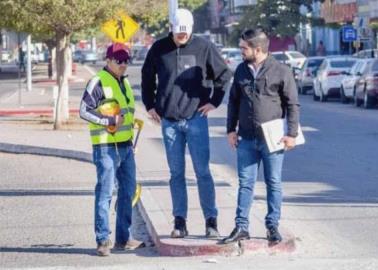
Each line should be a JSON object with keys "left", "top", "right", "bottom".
{"left": 142, "top": 9, "right": 232, "bottom": 238}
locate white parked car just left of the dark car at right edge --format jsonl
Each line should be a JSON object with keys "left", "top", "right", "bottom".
{"left": 340, "top": 59, "right": 372, "bottom": 103}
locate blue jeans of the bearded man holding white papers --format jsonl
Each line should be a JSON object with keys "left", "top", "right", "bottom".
{"left": 235, "top": 139, "right": 284, "bottom": 231}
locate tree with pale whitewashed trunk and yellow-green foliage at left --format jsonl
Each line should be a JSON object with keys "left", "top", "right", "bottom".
{"left": 0, "top": 0, "right": 125, "bottom": 129}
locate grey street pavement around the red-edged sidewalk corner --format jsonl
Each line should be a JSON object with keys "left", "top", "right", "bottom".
{"left": 0, "top": 65, "right": 378, "bottom": 269}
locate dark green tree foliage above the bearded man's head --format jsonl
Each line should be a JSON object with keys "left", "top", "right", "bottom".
{"left": 236, "top": 0, "right": 313, "bottom": 37}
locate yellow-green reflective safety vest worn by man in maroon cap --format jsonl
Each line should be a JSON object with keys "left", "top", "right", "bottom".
{"left": 89, "top": 70, "right": 135, "bottom": 145}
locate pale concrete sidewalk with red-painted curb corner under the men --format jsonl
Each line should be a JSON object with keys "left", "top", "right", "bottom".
{"left": 0, "top": 62, "right": 295, "bottom": 256}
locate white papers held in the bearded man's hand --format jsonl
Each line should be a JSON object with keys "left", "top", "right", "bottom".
{"left": 261, "top": 119, "right": 305, "bottom": 153}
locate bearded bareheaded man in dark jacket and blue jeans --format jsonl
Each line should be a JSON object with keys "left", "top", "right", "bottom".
{"left": 223, "top": 29, "right": 299, "bottom": 244}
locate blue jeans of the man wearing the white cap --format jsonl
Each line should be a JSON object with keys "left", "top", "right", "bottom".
{"left": 162, "top": 113, "right": 218, "bottom": 219}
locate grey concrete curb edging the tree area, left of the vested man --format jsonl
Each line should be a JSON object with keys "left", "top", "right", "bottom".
{"left": 0, "top": 143, "right": 92, "bottom": 163}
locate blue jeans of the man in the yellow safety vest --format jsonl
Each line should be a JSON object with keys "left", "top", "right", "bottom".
{"left": 93, "top": 145, "right": 136, "bottom": 244}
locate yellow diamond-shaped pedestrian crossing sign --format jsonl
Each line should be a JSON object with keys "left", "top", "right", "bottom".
{"left": 101, "top": 11, "right": 139, "bottom": 43}
